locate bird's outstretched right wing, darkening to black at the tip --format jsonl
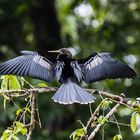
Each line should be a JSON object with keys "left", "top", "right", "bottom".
{"left": 79, "top": 53, "right": 136, "bottom": 83}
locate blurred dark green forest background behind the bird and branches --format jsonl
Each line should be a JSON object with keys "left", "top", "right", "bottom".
{"left": 0, "top": 0, "right": 140, "bottom": 140}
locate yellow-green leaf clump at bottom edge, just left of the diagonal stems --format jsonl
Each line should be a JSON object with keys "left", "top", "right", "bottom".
{"left": 70, "top": 128, "right": 86, "bottom": 140}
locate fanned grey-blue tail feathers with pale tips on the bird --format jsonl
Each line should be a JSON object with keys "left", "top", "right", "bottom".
{"left": 52, "top": 81, "right": 95, "bottom": 104}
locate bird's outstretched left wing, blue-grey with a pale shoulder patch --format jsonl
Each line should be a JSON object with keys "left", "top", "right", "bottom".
{"left": 0, "top": 51, "right": 54, "bottom": 81}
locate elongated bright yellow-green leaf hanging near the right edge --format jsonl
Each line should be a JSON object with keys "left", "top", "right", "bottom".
{"left": 130, "top": 112, "right": 138, "bottom": 133}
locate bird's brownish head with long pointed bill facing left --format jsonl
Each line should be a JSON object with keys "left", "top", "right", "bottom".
{"left": 48, "top": 48, "right": 72, "bottom": 58}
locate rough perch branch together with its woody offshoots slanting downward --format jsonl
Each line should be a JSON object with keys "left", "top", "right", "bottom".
{"left": 0, "top": 87, "right": 140, "bottom": 140}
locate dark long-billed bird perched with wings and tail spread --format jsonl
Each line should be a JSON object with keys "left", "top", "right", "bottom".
{"left": 0, "top": 48, "right": 136, "bottom": 104}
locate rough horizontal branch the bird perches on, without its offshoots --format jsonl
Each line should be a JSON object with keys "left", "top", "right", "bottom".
{"left": 0, "top": 87, "right": 140, "bottom": 109}
